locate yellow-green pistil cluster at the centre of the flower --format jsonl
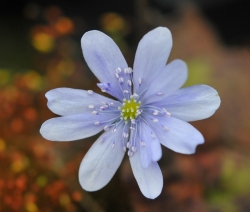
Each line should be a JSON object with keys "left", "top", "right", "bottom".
{"left": 119, "top": 98, "right": 141, "bottom": 121}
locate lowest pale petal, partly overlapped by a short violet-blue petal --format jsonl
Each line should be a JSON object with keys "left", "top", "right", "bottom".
{"left": 129, "top": 147, "right": 163, "bottom": 199}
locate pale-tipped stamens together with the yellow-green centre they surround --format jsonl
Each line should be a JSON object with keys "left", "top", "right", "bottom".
{"left": 88, "top": 68, "right": 173, "bottom": 156}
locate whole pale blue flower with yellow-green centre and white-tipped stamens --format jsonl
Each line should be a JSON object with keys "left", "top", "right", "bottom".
{"left": 40, "top": 27, "right": 220, "bottom": 199}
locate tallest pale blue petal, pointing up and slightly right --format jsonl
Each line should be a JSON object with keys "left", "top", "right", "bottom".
{"left": 133, "top": 27, "right": 172, "bottom": 94}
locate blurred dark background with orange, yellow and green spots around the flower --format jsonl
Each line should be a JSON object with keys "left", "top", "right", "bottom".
{"left": 0, "top": 0, "right": 250, "bottom": 212}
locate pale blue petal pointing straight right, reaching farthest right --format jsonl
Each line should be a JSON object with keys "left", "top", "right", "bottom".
{"left": 155, "top": 85, "right": 221, "bottom": 121}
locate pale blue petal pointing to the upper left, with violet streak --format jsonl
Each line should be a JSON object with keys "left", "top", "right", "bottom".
{"left": 81, "top": 30, "right": 128, "bottom": 100}
